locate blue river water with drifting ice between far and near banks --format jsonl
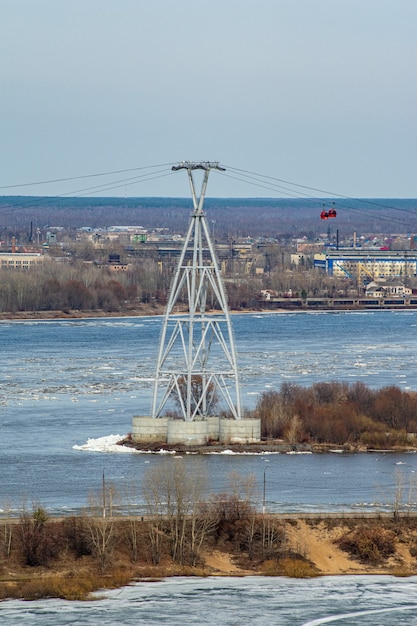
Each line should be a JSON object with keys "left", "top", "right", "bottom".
{"left": 0, "top": 311, "right": 417, "bottom": 514}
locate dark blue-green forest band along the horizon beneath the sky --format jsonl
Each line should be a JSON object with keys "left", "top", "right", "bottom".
{"left": 0, "top": 196, "right": 417, "bottom": 238}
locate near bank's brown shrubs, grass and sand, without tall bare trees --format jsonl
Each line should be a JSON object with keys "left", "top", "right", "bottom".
{"left": 0, "top": 510, "right": 417, "bottom": 600}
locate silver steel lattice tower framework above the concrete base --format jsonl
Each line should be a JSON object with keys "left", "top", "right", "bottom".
{"left": 151, "top": 161, "right": 241, "bottom": 421}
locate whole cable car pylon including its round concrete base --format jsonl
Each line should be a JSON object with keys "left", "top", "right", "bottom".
{"left": 132, "top": 161, "right": 260, "bottom": 445}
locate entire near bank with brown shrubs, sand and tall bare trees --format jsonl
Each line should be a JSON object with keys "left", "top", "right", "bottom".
{"left": 4, "top": 463, "right": 417, "bottom": 599}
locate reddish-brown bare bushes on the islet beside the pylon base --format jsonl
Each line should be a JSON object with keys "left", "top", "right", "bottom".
{"left": 255, "top": 381, "right": 417, "bottom": 449}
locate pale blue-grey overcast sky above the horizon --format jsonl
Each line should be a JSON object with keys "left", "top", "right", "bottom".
{"left": 0, "top": 0, "right": 417, "bottom": 198}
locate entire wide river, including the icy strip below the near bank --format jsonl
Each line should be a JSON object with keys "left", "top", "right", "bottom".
{"left": 0, "top": 311, "right": 417, "bottom": 626}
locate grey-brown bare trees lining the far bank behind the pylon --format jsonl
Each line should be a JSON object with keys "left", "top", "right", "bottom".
{"left": 0, "top": 246, "right": 362, "bottom": 313}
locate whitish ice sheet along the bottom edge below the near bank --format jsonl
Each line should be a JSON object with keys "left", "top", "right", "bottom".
{"left": 0, "top": 576, "right": 417, "bottom": 626}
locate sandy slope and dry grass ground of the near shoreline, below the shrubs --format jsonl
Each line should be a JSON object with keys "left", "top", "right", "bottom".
{"left": 0, "top": 514, "right": 417, "bottom": 600}
